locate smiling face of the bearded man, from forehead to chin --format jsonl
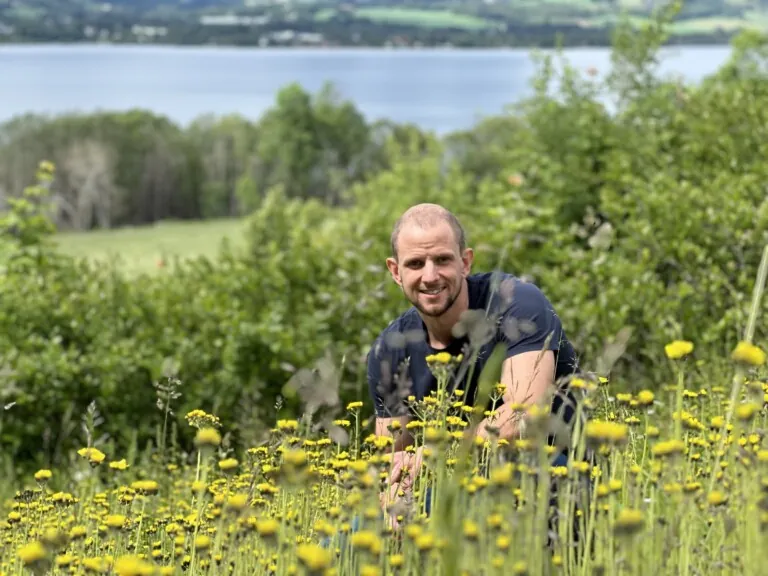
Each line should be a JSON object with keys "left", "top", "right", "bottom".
{"left": 387, "top": 222, "right": 472, "bottom": 317}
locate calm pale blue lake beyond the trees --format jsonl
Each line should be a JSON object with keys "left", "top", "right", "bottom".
{"left": 0, "top": 44, "right": 731, "bottom": 133}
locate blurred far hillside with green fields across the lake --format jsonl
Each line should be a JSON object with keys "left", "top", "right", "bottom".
{"left": 0, "top": 0, "right": 768, "bottom": 47}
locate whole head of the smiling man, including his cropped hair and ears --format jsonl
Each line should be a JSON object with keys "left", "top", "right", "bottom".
{"left": 387, "top": 204, "right": 473, "bottom": 317}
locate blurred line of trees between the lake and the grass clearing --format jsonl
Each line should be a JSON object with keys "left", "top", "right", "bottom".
{"left": 0, "top": 84, "right": 432, "bottom": 230}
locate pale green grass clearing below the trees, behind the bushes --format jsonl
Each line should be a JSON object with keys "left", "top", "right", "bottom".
{"left": 56, "top": 220, "right": 245, "bottom": 273}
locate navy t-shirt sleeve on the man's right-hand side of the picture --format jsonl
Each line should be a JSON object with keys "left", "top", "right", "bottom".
{"left": 499, "top": 281, "right": 562, "bottom": 358}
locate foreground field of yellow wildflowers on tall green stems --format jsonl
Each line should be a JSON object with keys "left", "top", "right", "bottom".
{"left": 0, "top": 328, "right": 768, "bottom": 575}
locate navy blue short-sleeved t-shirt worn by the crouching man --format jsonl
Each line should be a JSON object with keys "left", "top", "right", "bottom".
{"left": 368, "top": 272, "right": 578, "bottom": 420}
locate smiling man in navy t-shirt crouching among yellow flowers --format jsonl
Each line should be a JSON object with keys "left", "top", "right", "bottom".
{"left": 368, "top": 204, "right": 577, "bottom": 507}
